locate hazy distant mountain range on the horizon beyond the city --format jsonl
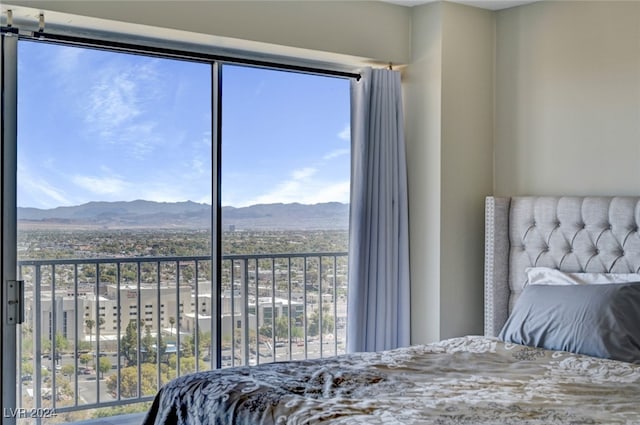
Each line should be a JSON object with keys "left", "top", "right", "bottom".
{"left": 17, "top": 200, "right": 349, "bottom": 230}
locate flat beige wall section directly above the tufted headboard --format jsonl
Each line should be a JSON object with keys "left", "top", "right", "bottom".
{"left": 495, "top": 1, "right": 640, "bottom": 195}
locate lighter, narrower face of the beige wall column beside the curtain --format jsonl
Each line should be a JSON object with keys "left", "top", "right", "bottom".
{"left": 403, "top": 3, "right": 442, "bottom": 343}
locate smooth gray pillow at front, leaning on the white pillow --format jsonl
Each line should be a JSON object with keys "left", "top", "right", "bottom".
{"left": 498, "top": 283, "right": 640, "bottom": 363}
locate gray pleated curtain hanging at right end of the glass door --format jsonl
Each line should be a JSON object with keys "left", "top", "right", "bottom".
{"left": 347, "top": 68, "right": 410, "bottom": 352}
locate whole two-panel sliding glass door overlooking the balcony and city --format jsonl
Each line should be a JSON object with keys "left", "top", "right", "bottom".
{"left": 2, "top": 31, "right": 350, "bottom": 424}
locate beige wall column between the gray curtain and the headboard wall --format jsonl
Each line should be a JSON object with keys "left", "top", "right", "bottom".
{"left": 404, "top": 3, "right": 495, "bottom": 343}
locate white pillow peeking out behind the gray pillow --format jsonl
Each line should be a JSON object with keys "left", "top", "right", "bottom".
{"left": 525, "top": 267, "right": 640, "bottom": 286}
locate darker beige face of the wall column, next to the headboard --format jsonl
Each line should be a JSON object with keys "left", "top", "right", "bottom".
{"left": 440, "top": 3, "right": 495, "bottom": 338}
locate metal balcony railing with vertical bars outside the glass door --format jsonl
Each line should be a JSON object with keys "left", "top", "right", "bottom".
{"left": 17, "top": 252, "right": 347, "bottom": 423}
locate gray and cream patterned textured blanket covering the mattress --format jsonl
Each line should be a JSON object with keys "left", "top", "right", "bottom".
{"left": 145, "top": 337, "right": 640, "bottom": 425}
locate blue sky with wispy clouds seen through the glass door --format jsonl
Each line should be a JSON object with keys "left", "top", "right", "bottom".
{"left": 18, "top": 42, "right": 350, "bottom": 208}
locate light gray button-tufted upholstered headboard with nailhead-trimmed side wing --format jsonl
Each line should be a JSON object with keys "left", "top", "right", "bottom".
{"left": 484, "top": 196, "right": 640, "bottom": 336}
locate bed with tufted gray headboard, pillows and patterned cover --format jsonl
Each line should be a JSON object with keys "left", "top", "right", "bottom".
{"left": 145, "top": 197, "right": 640, "bottom": 425}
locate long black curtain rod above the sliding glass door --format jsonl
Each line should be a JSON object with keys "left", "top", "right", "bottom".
{"left": 0, "top": 26, "right": 361, "bottom": 81}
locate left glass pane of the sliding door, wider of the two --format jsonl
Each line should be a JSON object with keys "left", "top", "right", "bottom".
{"left": 9, "top": 41, "right": 215, "bottom": 422}
